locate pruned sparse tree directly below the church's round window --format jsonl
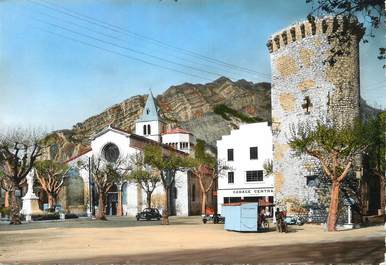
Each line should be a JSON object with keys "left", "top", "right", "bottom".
{"left": 84, "top": 157, "right": 128, "bottom": 221}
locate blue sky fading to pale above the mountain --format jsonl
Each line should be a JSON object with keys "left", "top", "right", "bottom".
{"left": 0, "top": 0, "right": 386, "bottom": 130}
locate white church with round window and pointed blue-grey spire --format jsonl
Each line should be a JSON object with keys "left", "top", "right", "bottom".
{"left": 66, "top": 94, "right": 199, "bottom": 216}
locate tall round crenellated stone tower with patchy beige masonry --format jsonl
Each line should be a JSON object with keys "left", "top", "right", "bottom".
{"left": 267, "top": 17, "right": 361, "bottom": 201}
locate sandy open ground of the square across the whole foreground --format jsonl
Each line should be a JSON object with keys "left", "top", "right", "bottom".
{"left": 0, "top": 217, "right": 385, "bottom": 264}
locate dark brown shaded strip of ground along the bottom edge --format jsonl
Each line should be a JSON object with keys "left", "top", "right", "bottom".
{"left": 35, "top": 237, "right": 385, "bottom": 264}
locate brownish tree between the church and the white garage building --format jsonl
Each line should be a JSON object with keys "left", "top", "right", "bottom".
{"left": 190, "top": 139, "right": 227, "bottom": 215}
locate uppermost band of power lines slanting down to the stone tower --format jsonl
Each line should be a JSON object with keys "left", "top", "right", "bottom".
{"left": 29, "top": 0, "right": 270, "bottom": 78}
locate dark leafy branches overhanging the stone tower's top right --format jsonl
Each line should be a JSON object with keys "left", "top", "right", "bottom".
{"left": 306, "top": 0, "right": 385, "bottom": 65}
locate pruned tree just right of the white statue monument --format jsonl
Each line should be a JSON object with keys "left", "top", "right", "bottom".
{"left": 34, "top": 160, "right": 70, "bottom": 208}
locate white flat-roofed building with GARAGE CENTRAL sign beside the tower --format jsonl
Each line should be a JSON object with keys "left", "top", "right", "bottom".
{"left": 217, "top": 122, "right": 274, "bottom": 214}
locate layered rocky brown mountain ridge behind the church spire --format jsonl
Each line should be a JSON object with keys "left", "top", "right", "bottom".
{"left": 45, "top": 77, "right": 271, "bottom": 160}
